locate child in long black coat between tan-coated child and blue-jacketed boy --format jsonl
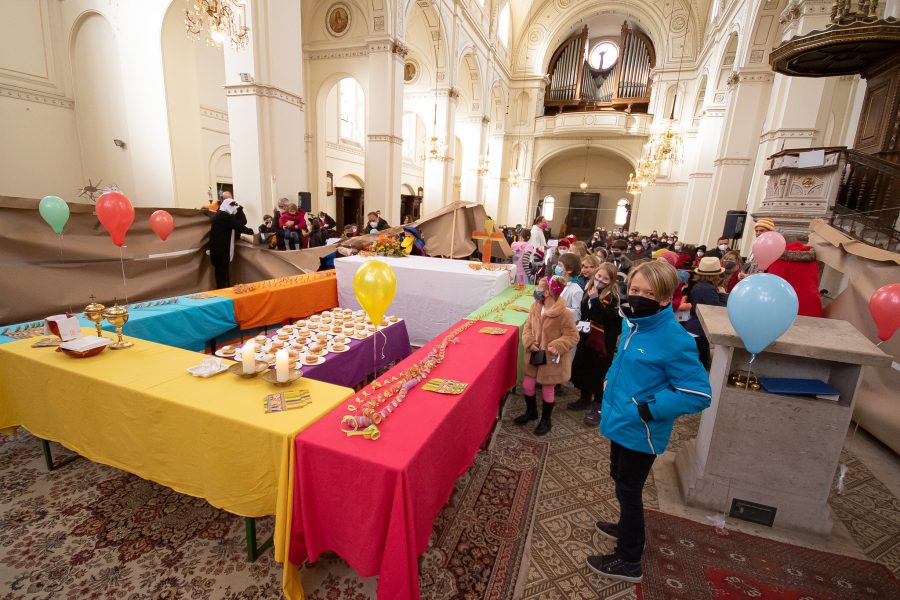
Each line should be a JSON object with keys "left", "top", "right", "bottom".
{"left": 566, "top": 263, "right": 622, "bottom": 427}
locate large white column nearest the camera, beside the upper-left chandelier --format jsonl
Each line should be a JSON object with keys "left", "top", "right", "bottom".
{"left": 225, "top": 0, "right": 306, "bottom": 224}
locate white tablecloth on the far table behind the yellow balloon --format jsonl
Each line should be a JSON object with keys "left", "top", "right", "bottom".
{"left": 334, "top": 256, "right": 515, "bottom": 346}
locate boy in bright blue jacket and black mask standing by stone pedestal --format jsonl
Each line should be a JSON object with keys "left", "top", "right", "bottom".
{"left": 587, "top": 261, "right": 711, "bottom": 583}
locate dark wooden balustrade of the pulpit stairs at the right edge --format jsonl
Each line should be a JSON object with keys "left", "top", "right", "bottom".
{"left": 831, "top": 150, "right": 900, "bottom": 252}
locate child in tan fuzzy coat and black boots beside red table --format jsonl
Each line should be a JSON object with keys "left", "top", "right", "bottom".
{"left": 514, "top": 277, "right": 578, "bottom": 436}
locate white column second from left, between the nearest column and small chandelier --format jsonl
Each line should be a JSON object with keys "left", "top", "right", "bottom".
{"left": 365, "top": 40, "right": 408, "bottom": 225}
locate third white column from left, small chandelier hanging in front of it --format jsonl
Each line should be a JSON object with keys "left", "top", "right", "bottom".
{"left": 422, "top": 88, "right": 459, "bottom": 214}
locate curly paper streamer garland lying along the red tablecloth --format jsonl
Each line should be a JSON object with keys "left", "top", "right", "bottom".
{"left": 341, "top": 321, "right": 475, "bottom": 440}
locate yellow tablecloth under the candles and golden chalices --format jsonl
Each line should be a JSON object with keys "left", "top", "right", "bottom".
{"left": 0, "top": 329, "right": 353, "bottom": 576}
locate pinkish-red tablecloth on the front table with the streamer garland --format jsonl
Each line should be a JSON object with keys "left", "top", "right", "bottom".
{"left": 285, "top": 321, "right": 519, "bottom": 600}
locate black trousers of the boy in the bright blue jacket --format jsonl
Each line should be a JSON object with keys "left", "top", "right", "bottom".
{"left": 609, "top": 440, "right": 656, "bottom": 562}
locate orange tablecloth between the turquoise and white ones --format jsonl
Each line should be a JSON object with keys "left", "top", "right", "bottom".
{"left": 210, "top": 271, "right": 337, "bottom": 329}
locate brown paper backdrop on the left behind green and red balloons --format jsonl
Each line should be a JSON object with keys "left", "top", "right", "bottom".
{"left": 0, "top": 196, "right": 316, "bottom": 325}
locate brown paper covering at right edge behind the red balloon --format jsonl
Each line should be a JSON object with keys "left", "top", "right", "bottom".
{"left": 809, "top": 220, "right": 900, "bottom": 453}
